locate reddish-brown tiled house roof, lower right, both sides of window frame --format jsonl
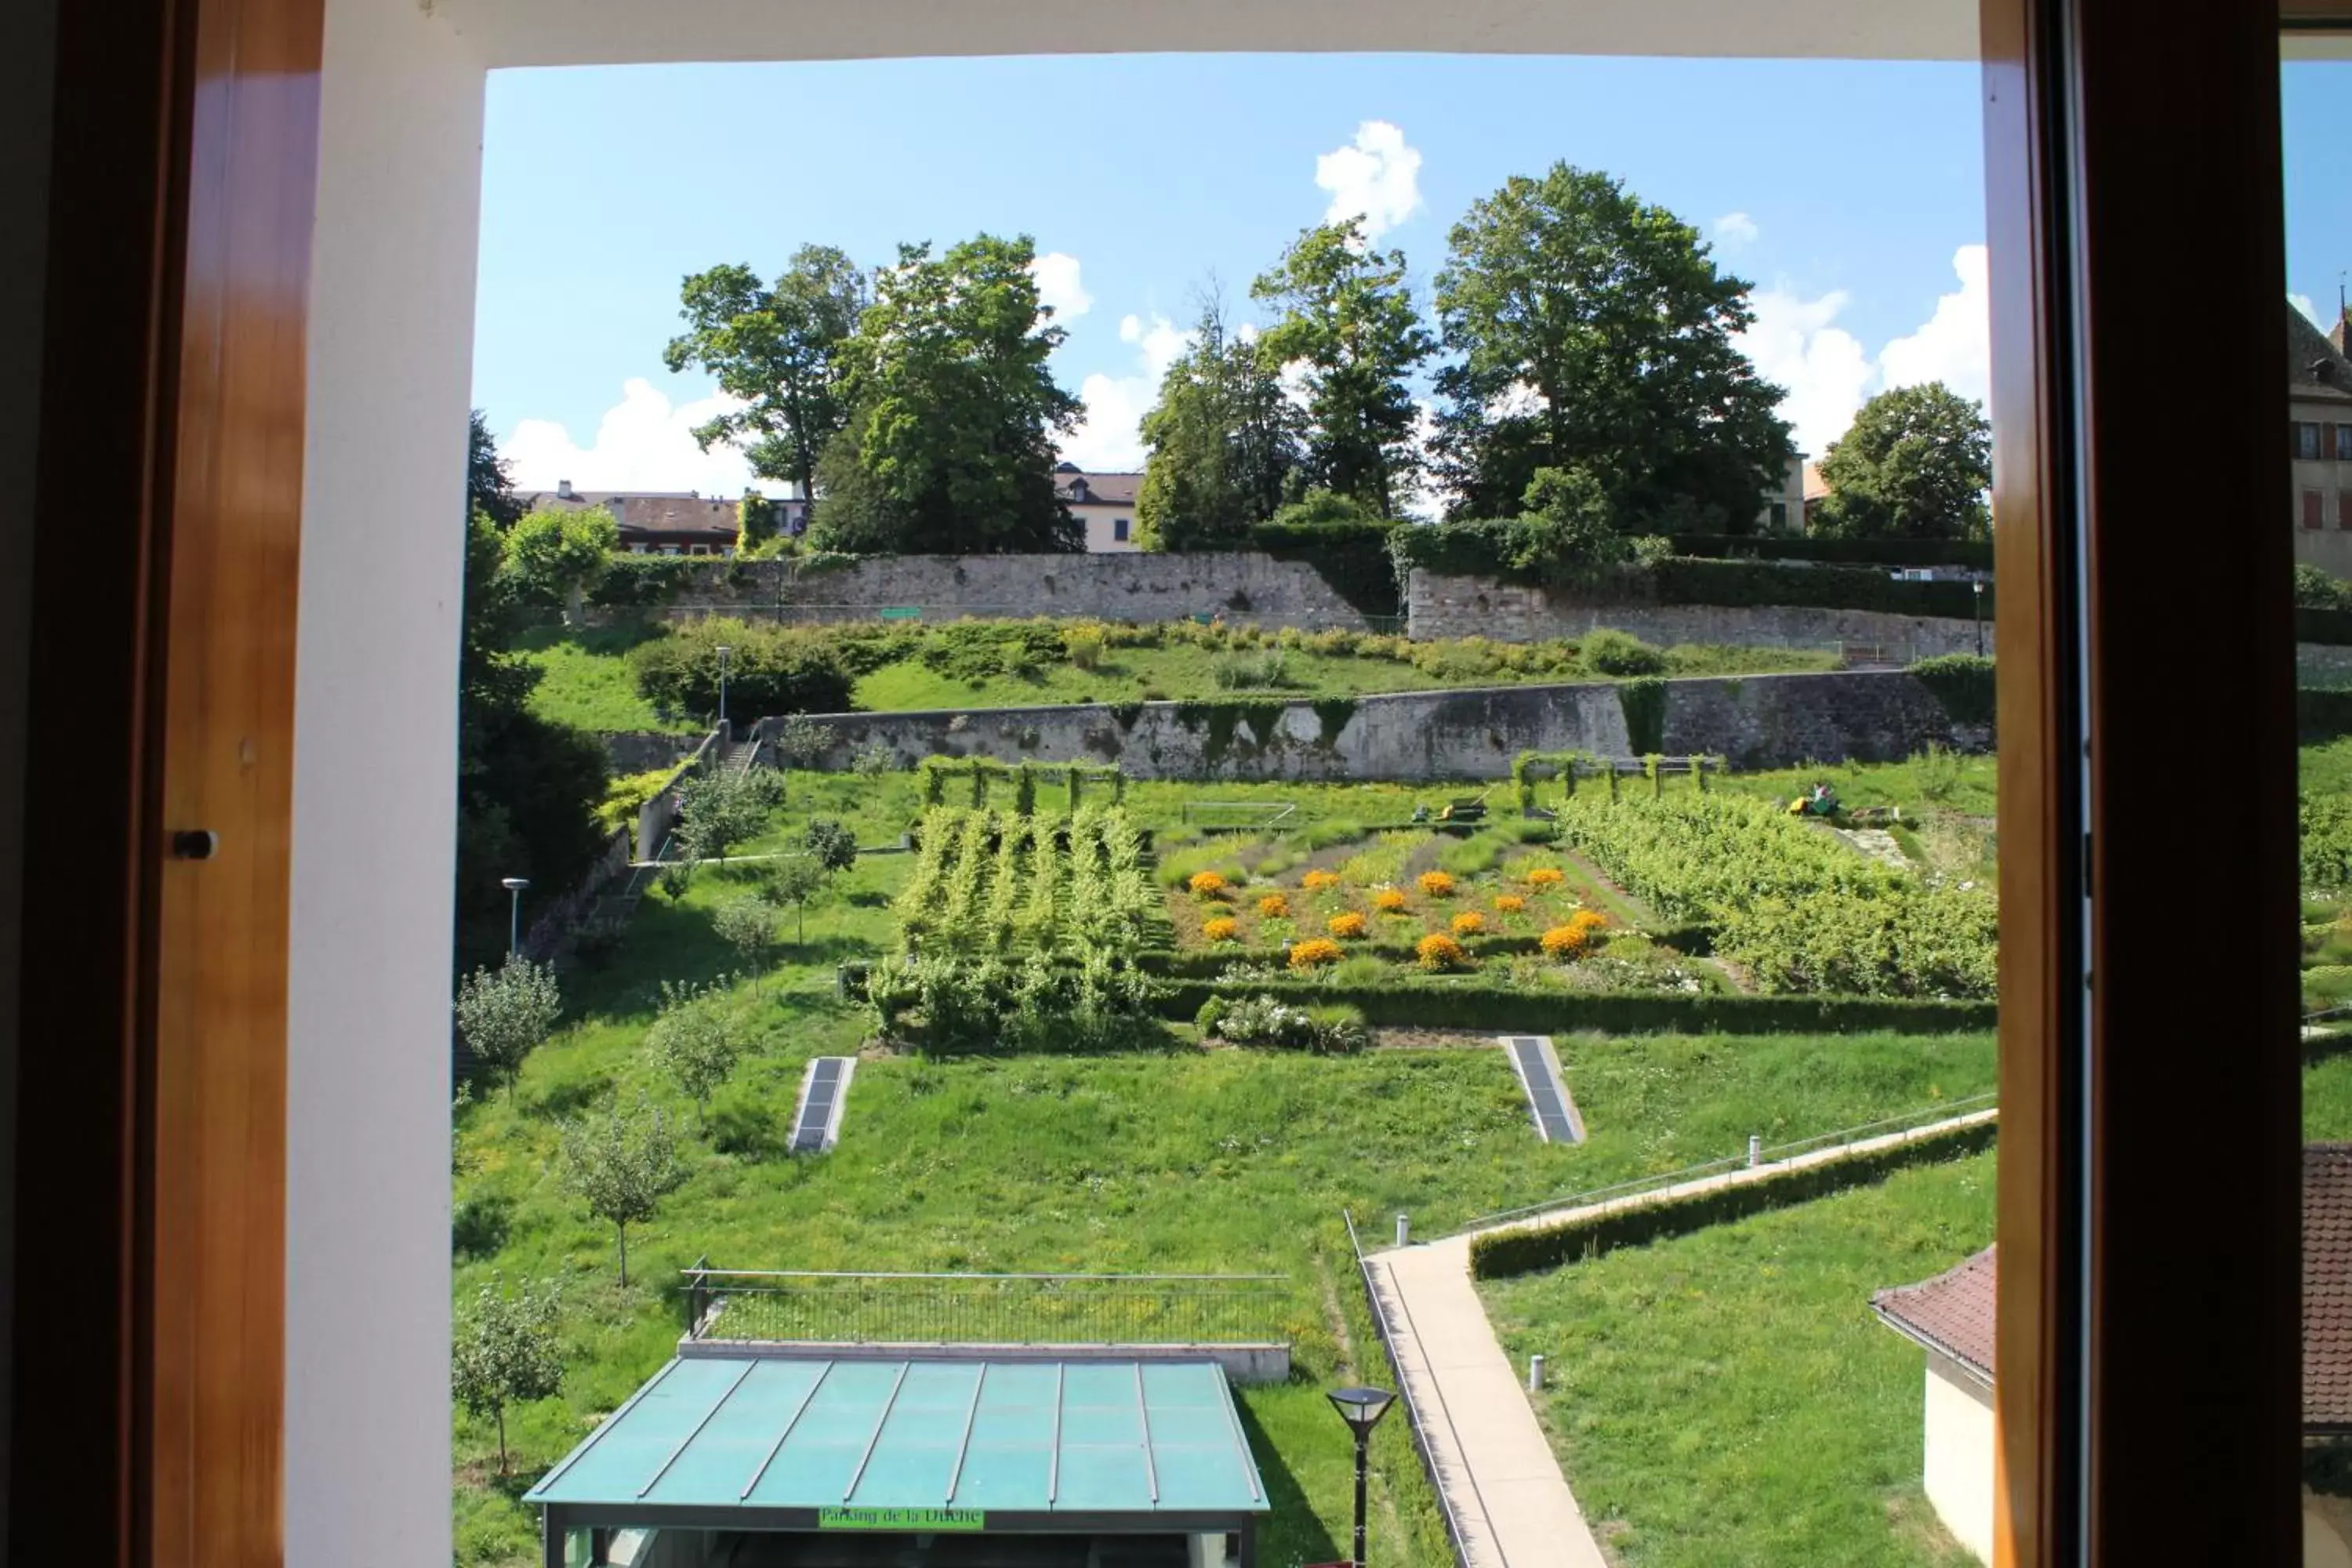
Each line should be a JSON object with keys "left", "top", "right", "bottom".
{"left": 1870, "top": 1142, "right": 2352, "bottom": 1432}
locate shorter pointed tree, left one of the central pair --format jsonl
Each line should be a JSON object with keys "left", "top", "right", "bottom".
{"left": 1136, "top": 294, "right": 1305, "bottom": 550}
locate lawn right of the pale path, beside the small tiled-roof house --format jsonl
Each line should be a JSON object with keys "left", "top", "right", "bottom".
{"left": 1479, "top": 1154, "right": 1994, "bottom": 1568}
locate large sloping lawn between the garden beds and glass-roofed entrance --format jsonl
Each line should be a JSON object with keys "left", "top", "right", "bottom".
{"left": 454, "top": 776, "right": 1992, "bottom": 1568}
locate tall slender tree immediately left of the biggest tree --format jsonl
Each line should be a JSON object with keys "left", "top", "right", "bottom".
{"left": 1249, "top": 219, "right": 1435, "bottom": 517}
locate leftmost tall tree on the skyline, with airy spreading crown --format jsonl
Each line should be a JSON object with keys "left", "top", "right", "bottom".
{"left": 663, "top": 245, "right": 873, "bottom": 514}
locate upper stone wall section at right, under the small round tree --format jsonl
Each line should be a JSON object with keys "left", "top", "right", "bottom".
{"left": 1404, "top": 569, "right": 1992, "bottom": 663}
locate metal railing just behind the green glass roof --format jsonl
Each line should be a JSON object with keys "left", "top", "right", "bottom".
{"left": 682, "top": 1265, "right": 1296, "bottom": 1345}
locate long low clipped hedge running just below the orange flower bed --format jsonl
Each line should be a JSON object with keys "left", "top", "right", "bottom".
{"left": 1162, "top": 978, "right": 1997, "bottom": 1034}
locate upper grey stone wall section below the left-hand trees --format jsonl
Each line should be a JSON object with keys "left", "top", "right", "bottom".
{"left": 630, "top": 553, "right": 1369, "bottom": 630}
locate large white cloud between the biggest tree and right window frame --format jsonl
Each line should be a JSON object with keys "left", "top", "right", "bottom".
{"left": 1738, "top": 245, "right": 1992, "bottom": 456}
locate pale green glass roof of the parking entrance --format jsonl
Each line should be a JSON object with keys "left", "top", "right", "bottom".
{"left": 529, "top": 1356, "right": 1265, "bottom": 1523}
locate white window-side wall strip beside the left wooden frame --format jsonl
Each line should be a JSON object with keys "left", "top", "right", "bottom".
{"left": 285, "top": 0, "right": 482, "bottom": 1568}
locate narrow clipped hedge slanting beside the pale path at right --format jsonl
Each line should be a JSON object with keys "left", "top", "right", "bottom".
{"left": 1470, "top": 1119, "right": 1999, "bottom": 1279}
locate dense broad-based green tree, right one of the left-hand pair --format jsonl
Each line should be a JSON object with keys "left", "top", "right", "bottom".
{"left": 809, "top": 235, "right": 1084, "bottom": 555}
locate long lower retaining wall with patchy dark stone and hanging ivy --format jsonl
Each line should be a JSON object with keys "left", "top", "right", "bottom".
{"left": 771, "top": 670, "right": 1990, "bottom": 781}
